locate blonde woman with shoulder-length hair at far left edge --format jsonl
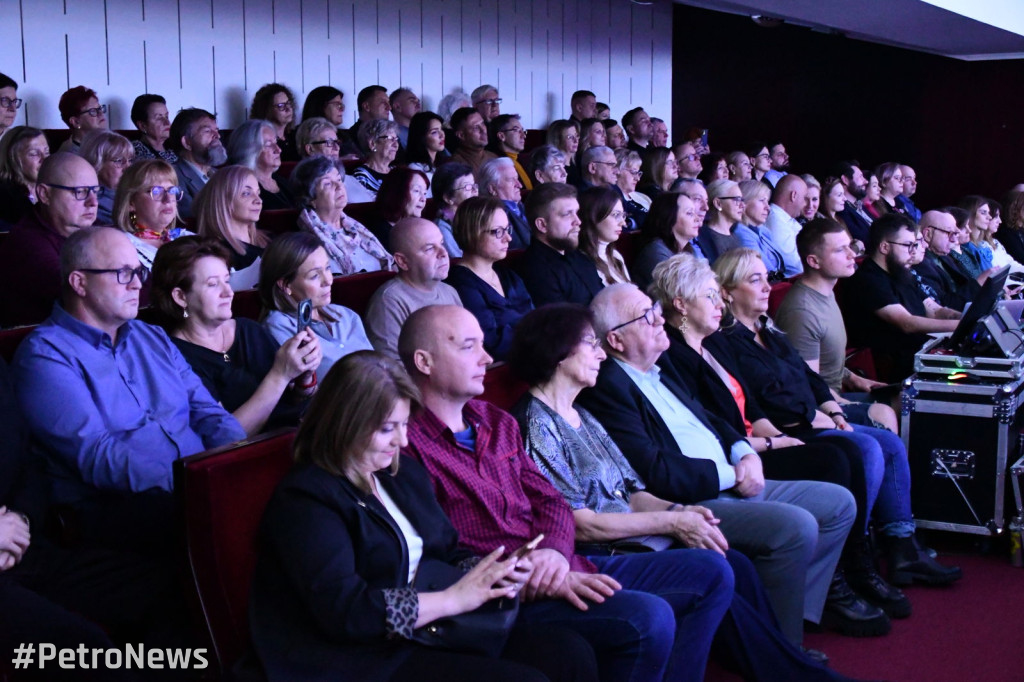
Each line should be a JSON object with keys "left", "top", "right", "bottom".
{"left": 0, "top": 126, "right": 50, "bottom": 225}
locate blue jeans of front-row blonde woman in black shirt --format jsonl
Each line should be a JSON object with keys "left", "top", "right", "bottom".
{"left": 818, "top": 424, "right": 914, "bottom": 538}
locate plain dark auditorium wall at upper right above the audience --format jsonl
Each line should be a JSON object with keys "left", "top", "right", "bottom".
{"left": 673, "top": 5, "right": 1024, "bottom": 208}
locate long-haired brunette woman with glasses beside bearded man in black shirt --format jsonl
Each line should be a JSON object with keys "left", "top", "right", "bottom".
{"left": 580, "top": 185, "right": 631, "bottom": 286}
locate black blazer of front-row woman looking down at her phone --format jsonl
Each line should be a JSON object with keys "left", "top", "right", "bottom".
{"left": 249, "top": 457, "right": 471, "bottom": 681}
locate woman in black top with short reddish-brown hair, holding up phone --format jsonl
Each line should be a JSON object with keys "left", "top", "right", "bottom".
{"left": 153, "top": 237, "right": 321, "bottom": 436}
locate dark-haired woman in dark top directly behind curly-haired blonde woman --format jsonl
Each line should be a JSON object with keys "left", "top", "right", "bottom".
{"left": 632, "top": 191, "right": 703, "bottom": 291}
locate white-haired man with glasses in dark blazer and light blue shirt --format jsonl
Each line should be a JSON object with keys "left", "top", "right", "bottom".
{"left": 579, "top": 284, "right": 856, "bottom": 643}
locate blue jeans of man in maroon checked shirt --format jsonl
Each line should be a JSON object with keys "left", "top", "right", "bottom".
{"left": 519, "top": 550, "right": 733, "bottom": 682}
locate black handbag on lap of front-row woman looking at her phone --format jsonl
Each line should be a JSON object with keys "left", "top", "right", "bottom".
{"left": 413, "top": 561, "right": 519, "bottom": 658}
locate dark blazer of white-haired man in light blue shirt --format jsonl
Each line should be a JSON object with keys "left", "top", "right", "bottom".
{"left": 578, "top": 358, "right": 742, "bottom": 504}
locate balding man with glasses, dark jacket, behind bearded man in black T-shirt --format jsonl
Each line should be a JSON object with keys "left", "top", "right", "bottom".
{"left": 913, "top": 209, "right": 981, "bottom": 310}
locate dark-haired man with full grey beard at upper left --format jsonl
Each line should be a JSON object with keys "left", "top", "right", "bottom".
{"left": 167, "top": 108, "right": 227, "bottom": 220}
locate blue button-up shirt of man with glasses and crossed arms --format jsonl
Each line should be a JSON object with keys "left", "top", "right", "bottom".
{"left": 12, "top": 303, "right": 246, "bottom": 504}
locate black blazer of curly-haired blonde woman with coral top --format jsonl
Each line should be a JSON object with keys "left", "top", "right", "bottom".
{"left": 657, "top": 326, "right": 765, "bottom": 433}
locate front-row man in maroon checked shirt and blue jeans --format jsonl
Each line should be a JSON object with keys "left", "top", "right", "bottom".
{"left": 398, "top": 306, "right": 831, "bottom": 680}
